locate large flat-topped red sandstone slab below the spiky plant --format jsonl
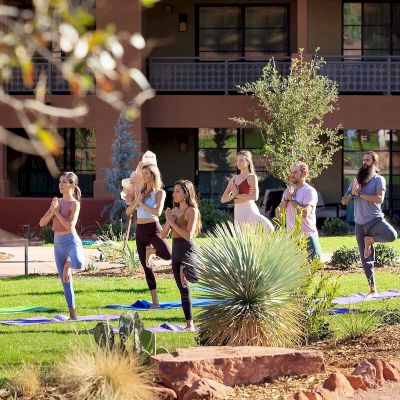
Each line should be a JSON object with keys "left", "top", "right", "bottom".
{"left": 152, "top": 346, "right": 325, "bottom": 396}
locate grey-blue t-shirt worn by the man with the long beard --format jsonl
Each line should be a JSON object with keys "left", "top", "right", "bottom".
{"left": 346, "top": 174, "right": 386, "bottom": 225}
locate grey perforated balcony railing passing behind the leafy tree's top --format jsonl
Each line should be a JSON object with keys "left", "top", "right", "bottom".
{"left": 148, "top": 56, "right": 400, "bottom": 94}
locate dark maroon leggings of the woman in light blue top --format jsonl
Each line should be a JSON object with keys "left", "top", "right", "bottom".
{"left": 136, "top": 221, "right": 171, "bottom": 290}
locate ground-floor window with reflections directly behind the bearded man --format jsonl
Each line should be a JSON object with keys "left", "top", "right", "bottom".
{"left": 343, "top": 129, "right": 400, "bottom": 213}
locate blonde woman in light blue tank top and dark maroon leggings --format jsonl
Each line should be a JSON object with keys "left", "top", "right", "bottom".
{"left": 126, "top": 164, "right": 171, "bottom": 308}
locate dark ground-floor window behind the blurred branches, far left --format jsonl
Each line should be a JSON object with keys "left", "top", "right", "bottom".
{"left": 7, "top": 128, "right": 96, "bottom": 197}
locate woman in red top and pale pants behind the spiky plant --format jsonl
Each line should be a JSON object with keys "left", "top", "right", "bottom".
{"left": 221, "top": 150, "right": 274, "bottom": 232}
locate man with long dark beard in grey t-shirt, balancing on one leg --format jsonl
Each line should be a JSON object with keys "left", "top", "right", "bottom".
{"left": 342, "top": 151, "right": 397, "bottom": 295}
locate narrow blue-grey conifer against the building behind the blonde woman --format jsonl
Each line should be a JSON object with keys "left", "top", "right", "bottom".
{"left": 105, "top": 115, "right": 141, "bottom": 220}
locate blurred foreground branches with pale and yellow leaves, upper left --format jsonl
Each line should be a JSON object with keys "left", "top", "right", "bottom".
{"left": 0, "top": 0, "right": 156, "bottom": 175}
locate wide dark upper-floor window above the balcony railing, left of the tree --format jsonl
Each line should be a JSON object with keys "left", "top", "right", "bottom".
{"left": 196, "top": 4, "right": 289, "bottom": 58}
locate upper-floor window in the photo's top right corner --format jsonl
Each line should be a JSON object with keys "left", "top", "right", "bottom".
{"left": 342, "top": 1, "right": 400, "bottom": 56}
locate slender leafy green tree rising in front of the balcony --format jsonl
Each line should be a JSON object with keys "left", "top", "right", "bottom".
{"left": 233, "top": 50, "right": 341, "bottom": 181}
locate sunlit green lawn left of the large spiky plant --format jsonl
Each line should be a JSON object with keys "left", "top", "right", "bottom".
{"left": 0, "top": 276, "right": 198, "bottom": 379}
